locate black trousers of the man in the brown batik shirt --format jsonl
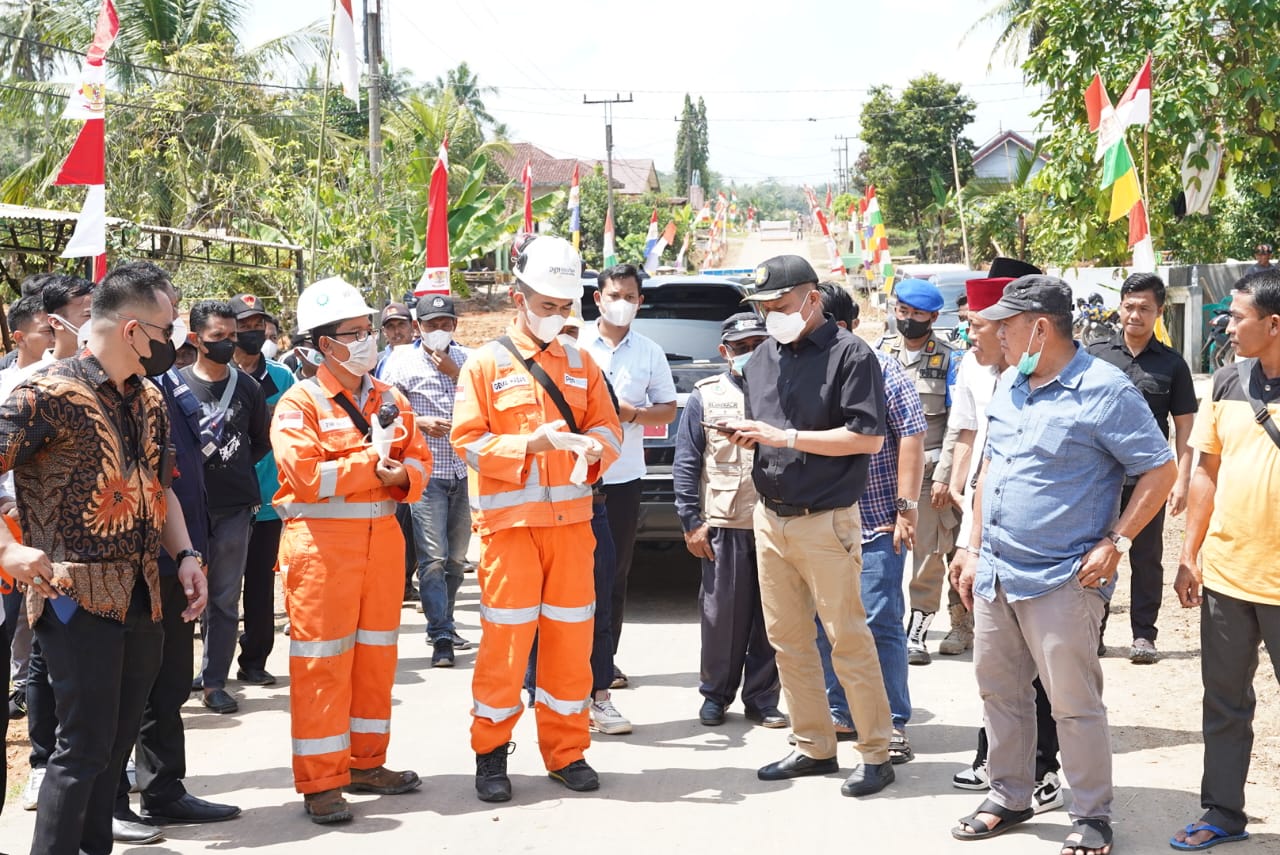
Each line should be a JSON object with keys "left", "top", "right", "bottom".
{"left": 31, "top": 584, "right": 164, "bottom": 855}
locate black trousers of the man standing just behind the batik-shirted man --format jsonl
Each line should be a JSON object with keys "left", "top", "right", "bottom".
{"left": 115, "top": 576, "right": 196, "bottom": 818}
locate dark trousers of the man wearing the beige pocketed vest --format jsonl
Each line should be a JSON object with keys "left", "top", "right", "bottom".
{"left": 698, "top": 529, "right": 782, "bottom": 710}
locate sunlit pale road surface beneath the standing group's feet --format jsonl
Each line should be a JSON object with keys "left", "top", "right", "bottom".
{"left": 0, "top": 550, "right": 1280, "bottom": 855}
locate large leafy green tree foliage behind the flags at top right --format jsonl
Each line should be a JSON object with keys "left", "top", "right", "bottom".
{"left": 1023, "top": 0, "right": 1280, "bottom": 264}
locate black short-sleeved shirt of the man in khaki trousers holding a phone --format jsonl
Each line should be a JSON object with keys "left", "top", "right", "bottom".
{"left": 742, "top": 319, "right": 884, "bottom": 511}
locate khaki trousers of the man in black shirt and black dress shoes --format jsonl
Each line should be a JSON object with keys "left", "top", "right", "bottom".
{"left": 754, "top": 503, "right": 890, "bottom": 763}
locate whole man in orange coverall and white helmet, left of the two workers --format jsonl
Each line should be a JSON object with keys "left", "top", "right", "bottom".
{"left": 271, "top": 279, "right": 431, "bottom": 823}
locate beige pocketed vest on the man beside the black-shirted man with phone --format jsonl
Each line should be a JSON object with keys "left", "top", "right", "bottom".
{"left": 694, "top": 374, "right": 756, "bottom": 529}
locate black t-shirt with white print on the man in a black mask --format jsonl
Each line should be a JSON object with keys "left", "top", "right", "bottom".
{"left": 180, "top": 366, "right": 271, "bottom": 511}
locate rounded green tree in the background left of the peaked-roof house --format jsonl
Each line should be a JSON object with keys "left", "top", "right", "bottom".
{"left": 856, "top": 73, "right": 975, "bottom": 260}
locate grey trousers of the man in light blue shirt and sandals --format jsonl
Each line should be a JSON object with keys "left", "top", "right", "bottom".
{"left": 973, "top": 575, "right": 1112, "bottom": 819}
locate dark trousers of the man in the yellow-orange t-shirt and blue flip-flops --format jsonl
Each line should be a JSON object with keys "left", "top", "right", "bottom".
{"left": 1201, "top": 587, "right": 1280, "bottom": 835}
